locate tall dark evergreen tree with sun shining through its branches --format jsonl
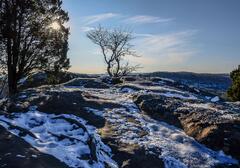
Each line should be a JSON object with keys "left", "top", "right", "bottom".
{"left": 0, "top": 0, "right": 69, "bottom": 94}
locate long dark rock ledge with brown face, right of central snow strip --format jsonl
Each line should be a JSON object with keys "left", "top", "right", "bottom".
{"left": 134, "top": 94, "right": 240, "bottom": 159}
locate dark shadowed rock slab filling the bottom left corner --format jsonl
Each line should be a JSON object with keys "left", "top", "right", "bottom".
{"left": 0, "top": 126, "right": 68, "bottom": 168}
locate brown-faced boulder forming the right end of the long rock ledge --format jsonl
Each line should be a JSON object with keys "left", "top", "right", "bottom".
{"left": 179, "top": 108, "right": 240, "bottom": 159}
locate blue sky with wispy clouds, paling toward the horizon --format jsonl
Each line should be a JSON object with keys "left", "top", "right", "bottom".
{"left": 63, "top": 0, "right": 240, "bottom": 73}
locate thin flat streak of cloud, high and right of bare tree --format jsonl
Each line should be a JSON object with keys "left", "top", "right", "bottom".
{"left": 123, "top": 15, "right": 174, "bottom": 24}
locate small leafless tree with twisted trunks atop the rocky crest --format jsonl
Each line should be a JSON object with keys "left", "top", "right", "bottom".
{"left": 87, "top": 25, "right": 139, "bottom": 77}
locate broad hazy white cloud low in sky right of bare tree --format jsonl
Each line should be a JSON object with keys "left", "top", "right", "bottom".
{"left": 132, "top": 30, "right": 197, "bottom": 65}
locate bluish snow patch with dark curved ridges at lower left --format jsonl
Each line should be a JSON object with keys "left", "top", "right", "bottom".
{"left": 0, "top": 110, "right": 117, "bottom": 168}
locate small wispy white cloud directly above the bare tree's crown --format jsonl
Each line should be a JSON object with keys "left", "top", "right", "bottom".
{"left": 83, "top": 13, "right": 119, "bottom": 25}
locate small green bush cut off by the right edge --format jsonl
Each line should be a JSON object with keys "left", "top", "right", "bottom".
{"left": 227, "top": 66, "right": 240, "bottom": 101}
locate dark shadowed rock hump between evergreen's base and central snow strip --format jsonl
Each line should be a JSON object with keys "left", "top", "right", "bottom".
{"left": 0, "top": 87, "right": 121, "bottom": 127}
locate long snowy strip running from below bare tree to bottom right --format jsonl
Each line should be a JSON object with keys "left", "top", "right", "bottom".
{"left": 83, "top": 90, "right": 237, "bottom": 168}
